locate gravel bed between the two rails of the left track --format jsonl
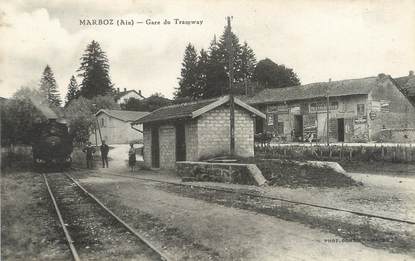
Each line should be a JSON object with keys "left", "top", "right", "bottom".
{"left": 48, "top": 174, "right": 160, "bottom": 260}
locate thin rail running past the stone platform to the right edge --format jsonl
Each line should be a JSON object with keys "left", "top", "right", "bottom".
{"left": 105, "top": 172, "right": 415, "bottom": 225}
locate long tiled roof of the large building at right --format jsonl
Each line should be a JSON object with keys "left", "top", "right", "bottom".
{"left": 241, "top": 77, "right": 379, "bottom": 104}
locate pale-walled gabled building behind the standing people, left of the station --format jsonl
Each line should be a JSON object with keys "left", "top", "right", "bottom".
{"left": 90, "top": 110, "right": 149, "bottom": 144}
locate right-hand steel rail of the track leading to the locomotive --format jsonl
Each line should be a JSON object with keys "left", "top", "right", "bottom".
{"left": 65, "top": 173, "right": 170, "bottom": 261}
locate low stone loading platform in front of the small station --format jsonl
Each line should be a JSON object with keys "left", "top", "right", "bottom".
{"left": 176, "top": 161, "right": 266, "bottom": 186}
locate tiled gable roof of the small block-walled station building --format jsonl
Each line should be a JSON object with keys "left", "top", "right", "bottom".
{"left": 135, "top": 96, "right": 265, "bottom": 123}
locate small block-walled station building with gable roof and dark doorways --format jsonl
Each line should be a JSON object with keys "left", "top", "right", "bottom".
{"left": 133, "top": 96, "right": 265, "bottom": 169}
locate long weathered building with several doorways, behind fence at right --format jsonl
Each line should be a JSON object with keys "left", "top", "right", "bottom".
{"left": 243, "top": 74, "right": 415, "bottom": 142}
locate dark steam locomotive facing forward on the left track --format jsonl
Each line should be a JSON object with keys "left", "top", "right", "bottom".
{"left": 32, "top": 119, "right": 73, "bottom": 170}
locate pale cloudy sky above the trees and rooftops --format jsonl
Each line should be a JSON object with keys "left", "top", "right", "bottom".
{"left": 0, "top": 0, "right": 415, "bottom": 98}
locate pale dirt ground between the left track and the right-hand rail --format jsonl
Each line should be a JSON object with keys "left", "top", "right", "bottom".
{"left": 77, "top": 171, "right": 412, "bottom": 260}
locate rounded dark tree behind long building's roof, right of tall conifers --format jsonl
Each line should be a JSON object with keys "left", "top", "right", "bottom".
{"left": 253, "top": 58, "right": 301, "bottom": 88}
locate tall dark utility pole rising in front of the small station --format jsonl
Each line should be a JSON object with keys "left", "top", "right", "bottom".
{"left": 226, "top": 16, "right": 235, "bottom": 156}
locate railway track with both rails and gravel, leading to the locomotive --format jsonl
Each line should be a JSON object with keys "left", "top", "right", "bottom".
{"left": 43, "top": 173, "right": 169, "bottom": 261}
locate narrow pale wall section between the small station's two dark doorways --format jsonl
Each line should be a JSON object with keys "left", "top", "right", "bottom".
{"left": 159, "top": 124, "right": 176, "bottom": 169}
